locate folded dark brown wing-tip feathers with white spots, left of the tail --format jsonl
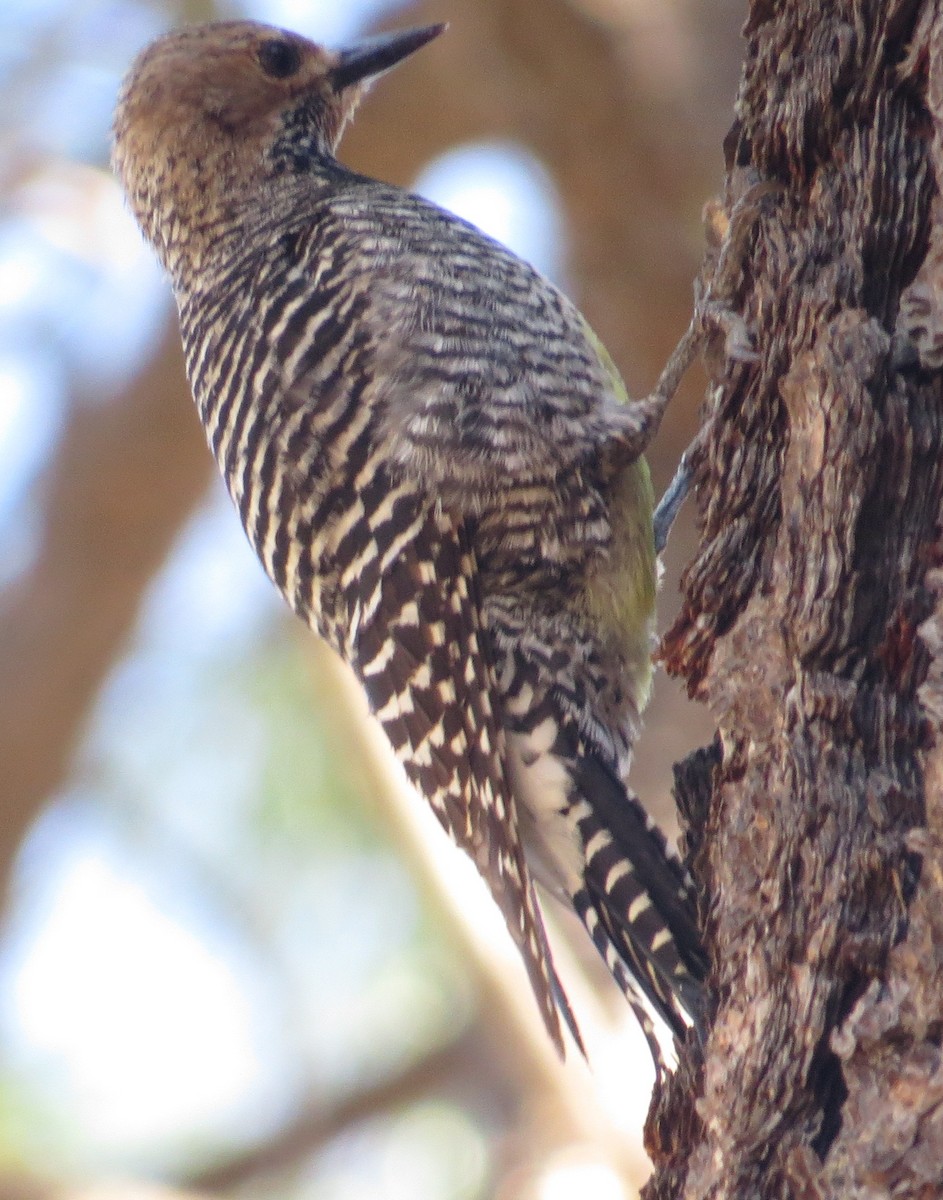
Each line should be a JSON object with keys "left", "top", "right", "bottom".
{"left": 352, "top": 487, "right": 582, "bottom": 1052}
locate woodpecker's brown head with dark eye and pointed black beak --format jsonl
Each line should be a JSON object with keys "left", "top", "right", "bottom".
{"left": 113, "top": 20, "right": 444, "bottom": 270}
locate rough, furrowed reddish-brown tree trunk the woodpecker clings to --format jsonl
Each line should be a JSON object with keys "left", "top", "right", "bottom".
{"left": 648, "top": 0, "right": 943, "bottom": 1200}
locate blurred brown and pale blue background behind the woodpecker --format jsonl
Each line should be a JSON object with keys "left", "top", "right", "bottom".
{"left": 0, "top": 0, "right": 745, "bottom": 1200}
